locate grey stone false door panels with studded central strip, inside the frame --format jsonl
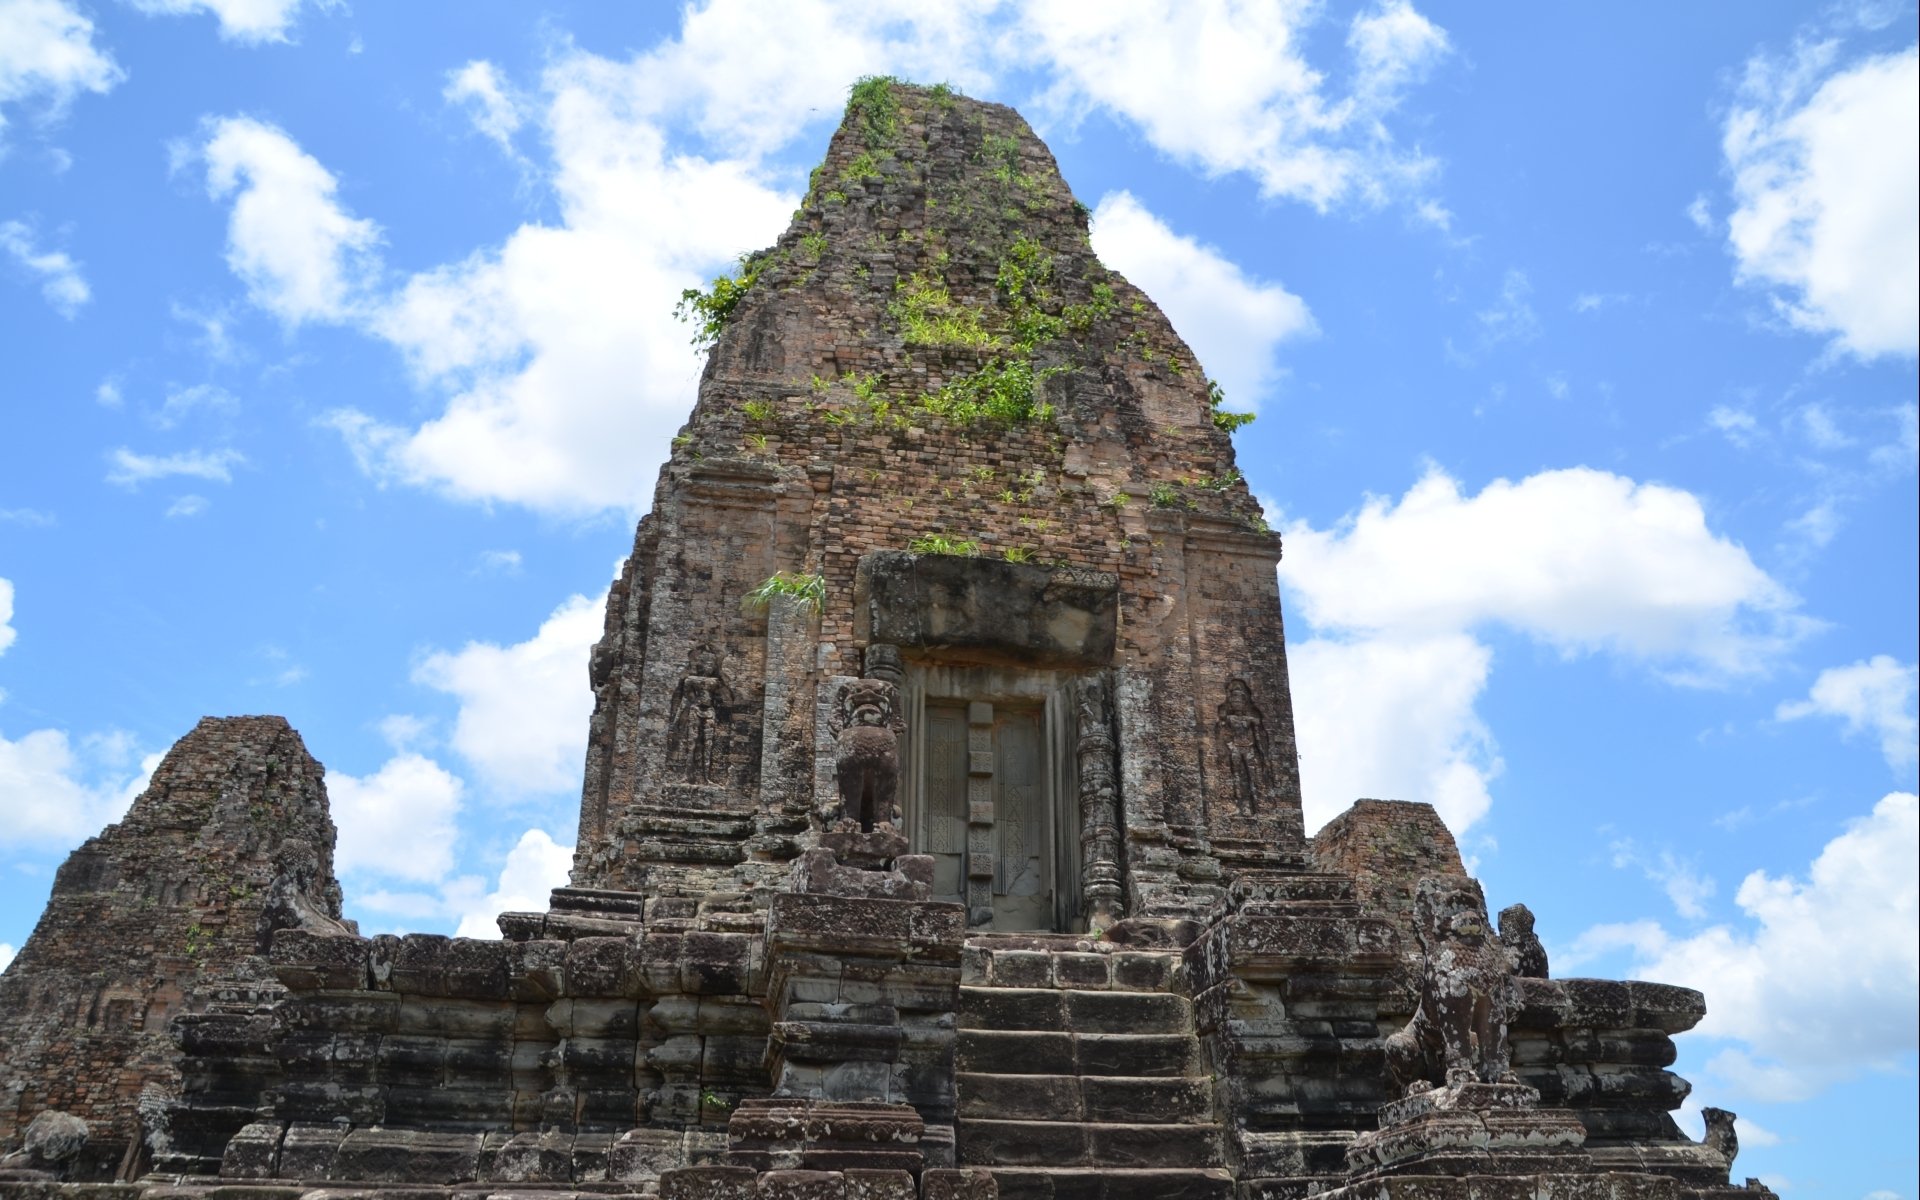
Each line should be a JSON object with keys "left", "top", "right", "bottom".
{"left": 916, "top": 701, "right": 1054, "bottom": 929}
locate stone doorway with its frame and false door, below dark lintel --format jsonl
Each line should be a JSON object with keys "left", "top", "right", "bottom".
{"left": 902, "top": 668, "right": 1081, "bottom": 931}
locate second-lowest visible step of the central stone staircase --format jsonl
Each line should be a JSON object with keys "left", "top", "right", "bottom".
{"left": 954, "top": 1119, "right": 1225, "bottom": 1169}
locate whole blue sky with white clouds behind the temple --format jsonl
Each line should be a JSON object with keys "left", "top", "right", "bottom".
{"left": 0, "top": 0, "right": 1920, "bottom": 1200}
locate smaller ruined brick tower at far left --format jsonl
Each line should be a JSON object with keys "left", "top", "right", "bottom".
{"left": 0, "top": 716, "right": 346, "bottom": 1173}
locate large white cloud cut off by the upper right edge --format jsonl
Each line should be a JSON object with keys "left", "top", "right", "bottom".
{"left": 1722, "top": 42, "right": 1920, "bottom": 359}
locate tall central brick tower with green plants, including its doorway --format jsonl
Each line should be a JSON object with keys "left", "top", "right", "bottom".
{"left": 557, "top": 84, "right": 1306, "bottom": 931}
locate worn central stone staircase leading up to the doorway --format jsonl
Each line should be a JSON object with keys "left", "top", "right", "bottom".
{"left": 954, "top": 935, "right": 1233, "bottom": 1200}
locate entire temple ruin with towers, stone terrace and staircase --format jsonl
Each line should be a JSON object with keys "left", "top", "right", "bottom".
{"left": 0, "top": 81, "right": 1764, "bottom": 1200}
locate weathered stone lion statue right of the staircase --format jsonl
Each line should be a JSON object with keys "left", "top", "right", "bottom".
{"left": 1386, "top": 876, "right": 1517, "bottom": 1094}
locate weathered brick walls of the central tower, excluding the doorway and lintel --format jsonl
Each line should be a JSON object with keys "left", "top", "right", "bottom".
{"left": 574, "top": 86, "right": 1304, "bottom": 912}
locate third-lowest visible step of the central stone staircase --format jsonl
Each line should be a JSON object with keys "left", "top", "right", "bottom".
{"left": 954, "top": 1073, "right": 1213, "bottom": 1125}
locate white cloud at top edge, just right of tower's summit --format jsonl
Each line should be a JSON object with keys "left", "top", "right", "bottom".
{"left": 1016, "top": 0, "right": 1448, "bottom": 209}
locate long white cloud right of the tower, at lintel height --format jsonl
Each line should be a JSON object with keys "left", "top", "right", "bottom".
{"left": 1281, "top": 467, "right": 1811, "bottom": 682}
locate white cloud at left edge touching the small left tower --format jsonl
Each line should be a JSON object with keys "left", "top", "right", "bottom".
{"left": 0, "top": 730, "right": 159, "bottom": 847}
